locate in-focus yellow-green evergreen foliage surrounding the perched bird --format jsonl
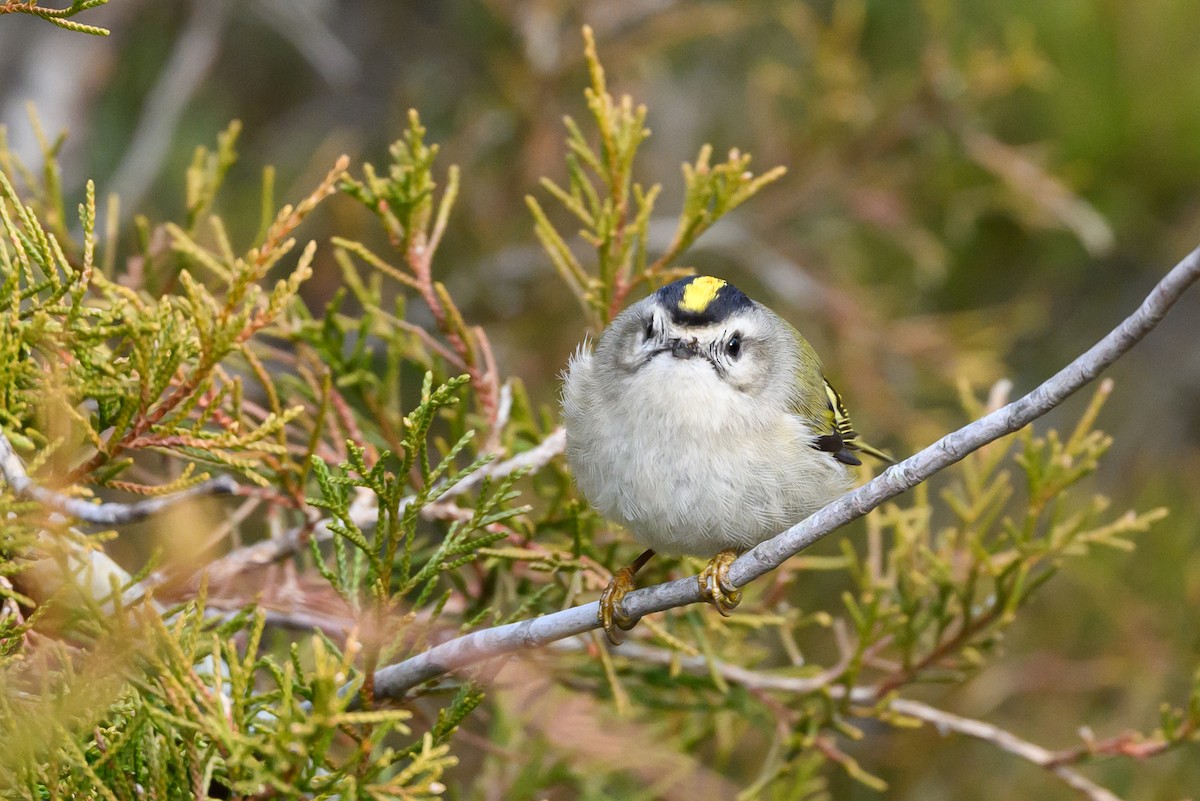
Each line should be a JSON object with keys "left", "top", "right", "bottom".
{"left": 0, "top": 23, "right": 1200, "bottom": 799}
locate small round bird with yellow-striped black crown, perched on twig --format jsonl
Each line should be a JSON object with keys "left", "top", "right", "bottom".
{"left": 563, "top": 276, "right": 893, "bottom": 644}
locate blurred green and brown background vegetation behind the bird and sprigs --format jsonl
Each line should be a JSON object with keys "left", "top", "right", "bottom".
{"left": 0, "top": 0, "right": 1200, "bottom": 800}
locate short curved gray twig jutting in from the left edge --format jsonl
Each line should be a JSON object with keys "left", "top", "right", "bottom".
{"left": 0, "top": 430, "right": 238, "bottom": 525}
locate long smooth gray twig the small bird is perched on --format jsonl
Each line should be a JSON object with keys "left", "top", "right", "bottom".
{"left": 364, "top": 248, "right": 1200, "bottom": 699}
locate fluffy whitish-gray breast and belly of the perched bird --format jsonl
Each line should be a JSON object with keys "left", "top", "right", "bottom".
{"left": 564, "top": 364, "right": 850, "bottom": 556}
